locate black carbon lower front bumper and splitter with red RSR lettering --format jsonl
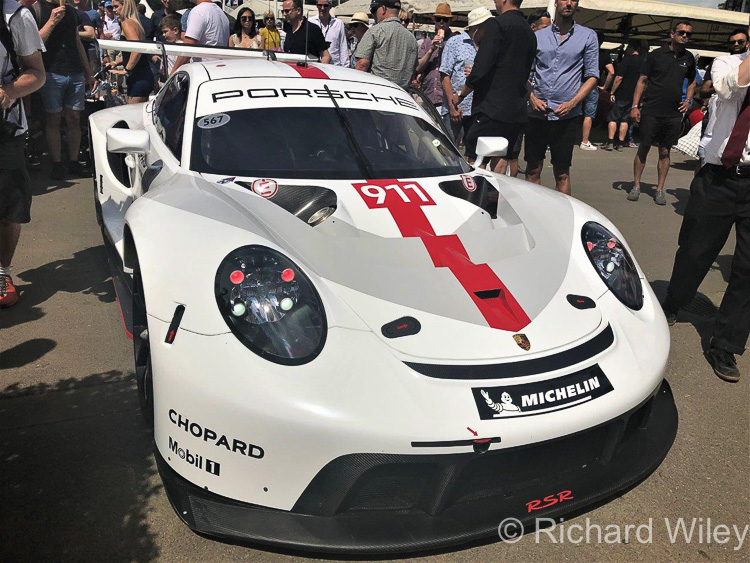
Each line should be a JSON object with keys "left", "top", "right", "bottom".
{"left": 156, "top": 381, "right": 677, "bottom": 554}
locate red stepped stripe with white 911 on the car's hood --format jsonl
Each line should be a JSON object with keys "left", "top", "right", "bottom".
{"left": 353, "top": 180, "right": 531, "bottom": 332}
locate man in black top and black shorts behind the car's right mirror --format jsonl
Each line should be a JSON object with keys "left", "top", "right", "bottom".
{"left": 454, "top": 0, "right": 536, "bottom": 174}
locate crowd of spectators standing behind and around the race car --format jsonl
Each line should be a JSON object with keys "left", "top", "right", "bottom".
{"left": 0, "top": 0, "right": 750, "bottom": 381}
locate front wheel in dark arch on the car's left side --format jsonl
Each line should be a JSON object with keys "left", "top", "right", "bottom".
{"left": 133, "top": 262, "right": 154, "bottom": 428}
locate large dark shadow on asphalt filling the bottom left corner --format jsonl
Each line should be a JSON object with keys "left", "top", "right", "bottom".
{"left": 0, "top": 371, "right": 162, "bottom": 561}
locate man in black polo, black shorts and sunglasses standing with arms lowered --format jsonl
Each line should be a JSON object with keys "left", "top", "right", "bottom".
{"left": 628, "top": 21, "right": 695, "bottom": 205}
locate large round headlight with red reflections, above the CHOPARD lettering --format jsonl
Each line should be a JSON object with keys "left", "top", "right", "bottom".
{"left": 214, "top": 246, "right": 327, "bottom": 365}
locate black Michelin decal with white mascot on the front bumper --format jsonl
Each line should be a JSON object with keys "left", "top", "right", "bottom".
{"left": 471, "top": 365, "right": 614, "bottom": 420}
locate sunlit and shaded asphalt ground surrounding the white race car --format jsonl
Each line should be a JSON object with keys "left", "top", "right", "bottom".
{"left": 0, "top": 140, "right": 750, "bottom": 562}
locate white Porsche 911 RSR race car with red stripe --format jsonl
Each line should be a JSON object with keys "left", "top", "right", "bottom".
{"left": 91, "top": 41, "right": 677, "bottom": 553}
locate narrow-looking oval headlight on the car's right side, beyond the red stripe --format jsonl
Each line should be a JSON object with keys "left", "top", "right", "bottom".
{"left": 581, "top": 222, "right": 643, "bottom": 311}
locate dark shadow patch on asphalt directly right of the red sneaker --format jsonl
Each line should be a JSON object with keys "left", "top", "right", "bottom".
{"left": 0, "top": 245, "right": 115, "bottom": 328}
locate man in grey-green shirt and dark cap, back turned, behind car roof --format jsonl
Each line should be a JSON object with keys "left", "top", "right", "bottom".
{"left": 354, "top": 0, "right": 417, "bottom": 88}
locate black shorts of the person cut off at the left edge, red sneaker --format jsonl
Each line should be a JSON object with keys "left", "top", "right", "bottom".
{"left": 0, "top": 135, "right": 31, "bottom": 223}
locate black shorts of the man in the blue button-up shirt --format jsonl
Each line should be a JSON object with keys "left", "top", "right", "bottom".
{"left": 524, "top": 116, "right": 581, "bottom": 168}
